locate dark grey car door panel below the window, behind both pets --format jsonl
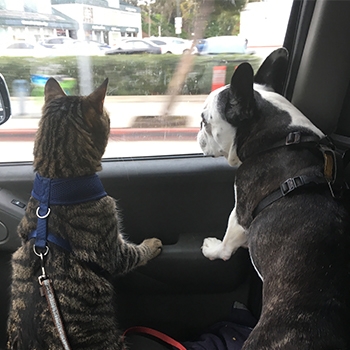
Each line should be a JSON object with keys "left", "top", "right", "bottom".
{"left": 0, "top": 156, "right": 260, "bottom": 348}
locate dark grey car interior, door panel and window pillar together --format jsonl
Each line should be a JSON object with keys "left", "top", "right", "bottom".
{"left": 0, "top": 0, "right": 350, "bottom": 349}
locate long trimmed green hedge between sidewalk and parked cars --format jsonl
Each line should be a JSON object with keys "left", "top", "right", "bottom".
{"left": 0, "top": 55, "right": 261, "bottom": 95}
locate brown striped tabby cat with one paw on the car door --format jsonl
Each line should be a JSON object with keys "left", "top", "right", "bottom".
{"left": 7, "top": 78, "right": 162, "bottom": 350}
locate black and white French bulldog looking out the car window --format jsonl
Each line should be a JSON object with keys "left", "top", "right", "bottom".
{"left": 198, "top": 48, "right": 350, "bottom": 350}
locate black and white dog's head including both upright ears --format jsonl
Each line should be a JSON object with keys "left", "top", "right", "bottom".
{"left": 197, "top": 48, "right": 294, "bottom": 166}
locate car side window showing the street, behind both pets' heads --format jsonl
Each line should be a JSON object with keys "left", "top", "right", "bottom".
{"left": 0, "top": 0, "right": 292, "bottom": 162}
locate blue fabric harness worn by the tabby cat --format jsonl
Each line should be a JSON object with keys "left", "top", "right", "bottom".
{"left": 28, "top": 174, "right": 107, "bottom": 250}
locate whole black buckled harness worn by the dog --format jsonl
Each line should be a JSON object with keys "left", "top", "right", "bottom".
{"left": 253, "top": 131, "right": 347, "bottom": 219}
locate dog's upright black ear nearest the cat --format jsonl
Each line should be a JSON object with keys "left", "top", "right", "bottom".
{"left": 225, "top": 62, "right": 254, "bottom": 123}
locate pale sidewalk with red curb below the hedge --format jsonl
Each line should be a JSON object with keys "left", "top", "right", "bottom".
{"left": 0, "top": 95, "right": 206, "bottom": 141}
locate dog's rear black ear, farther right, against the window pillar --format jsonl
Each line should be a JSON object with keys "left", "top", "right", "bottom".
{"left": 254, "top": 47, "right": 288, "bottom": 94}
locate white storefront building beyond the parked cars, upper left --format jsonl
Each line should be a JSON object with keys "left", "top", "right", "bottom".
{"left": 0, "top": 0, "right": 142, "bottom": 45}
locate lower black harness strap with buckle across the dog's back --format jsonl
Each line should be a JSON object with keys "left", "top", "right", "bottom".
{"left": 253, "top": 175, "right": 327, "bottom": 219}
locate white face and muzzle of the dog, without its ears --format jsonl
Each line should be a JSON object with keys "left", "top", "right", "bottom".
{"left": 197, "top": 85, "right": 241, "bottom": 166}
